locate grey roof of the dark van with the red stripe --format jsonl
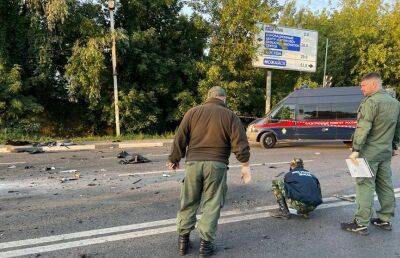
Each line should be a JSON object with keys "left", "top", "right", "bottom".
{"left": 285, "top": 87, "right": 363, "bottom": 104}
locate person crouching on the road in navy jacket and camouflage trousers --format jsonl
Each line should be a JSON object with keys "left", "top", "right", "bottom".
{"left": 272, "top": 158, "right": 322, "bottom": 219}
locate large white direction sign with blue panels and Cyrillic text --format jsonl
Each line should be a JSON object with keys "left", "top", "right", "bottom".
{"left": 253, "top": 24, "right": 318, "bottom": 72}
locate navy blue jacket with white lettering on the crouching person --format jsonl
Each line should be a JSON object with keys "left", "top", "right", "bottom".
{"left": 284, "top": 168, "right": 322, "bottom": 207}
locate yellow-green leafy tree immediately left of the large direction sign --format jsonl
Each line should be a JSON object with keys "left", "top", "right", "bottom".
{"left": 192, "top": 0, "right": 279, "bottom": 115}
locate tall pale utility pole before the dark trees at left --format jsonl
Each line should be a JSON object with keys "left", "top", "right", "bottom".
{"left": 108, "top": 0, "right": 120, "bottom": 137}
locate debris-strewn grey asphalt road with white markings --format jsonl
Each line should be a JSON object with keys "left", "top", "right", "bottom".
{"left": 0, "top": 143, "right": 400, "bottom": 257}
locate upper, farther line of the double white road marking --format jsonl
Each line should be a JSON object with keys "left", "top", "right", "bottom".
{"left": 0, "top": 188, "right": 400, "bottom": 250}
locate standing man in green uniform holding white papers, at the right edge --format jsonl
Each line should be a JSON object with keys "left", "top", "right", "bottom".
{"left": 341, "top": 73, "right": 400, "bottom": 235}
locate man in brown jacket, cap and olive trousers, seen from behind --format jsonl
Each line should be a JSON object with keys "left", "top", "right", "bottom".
{"left": 167, "top": 86, "right": 250, "bottom": 257}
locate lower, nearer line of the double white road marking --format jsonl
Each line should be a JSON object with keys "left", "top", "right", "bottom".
{"left": 0, "top": 193, "right": 400, "bottom": 258}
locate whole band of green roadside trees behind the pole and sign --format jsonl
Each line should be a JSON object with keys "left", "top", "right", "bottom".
{"left": 0, "top": 0, "right": 400, "bottom": 141}
